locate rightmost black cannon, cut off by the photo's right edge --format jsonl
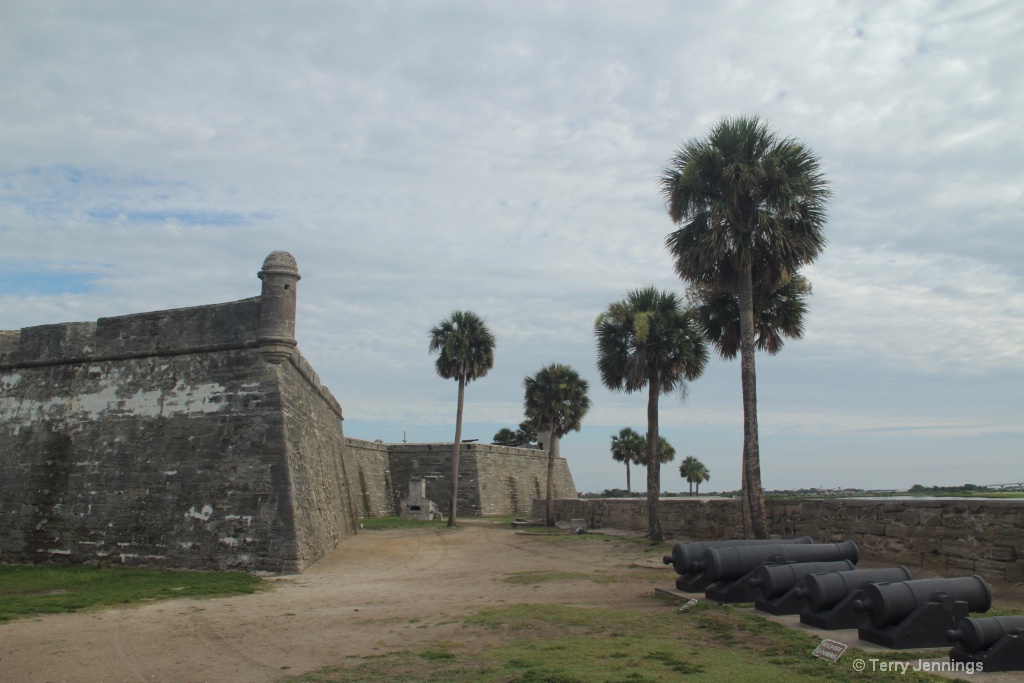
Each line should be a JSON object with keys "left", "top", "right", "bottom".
{"left": 946, "top": 616, "right": 1024, "bottom": 672}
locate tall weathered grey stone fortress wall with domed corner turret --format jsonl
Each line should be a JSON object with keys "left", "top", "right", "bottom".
{"left": 0, "top": 252, "right": 575, "bottom": 572}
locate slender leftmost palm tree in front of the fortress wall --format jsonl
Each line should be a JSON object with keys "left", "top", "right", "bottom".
{"left": 430, "top": 310, "right": 495, "bottom": 526}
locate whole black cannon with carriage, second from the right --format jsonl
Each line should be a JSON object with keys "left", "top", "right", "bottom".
{"left": 853, "top": 575, "right": 992, "bottom": 649}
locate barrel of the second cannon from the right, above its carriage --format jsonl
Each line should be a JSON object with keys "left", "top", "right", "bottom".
{"left": 853, "top": 574, "right": 992, "bottom": 628}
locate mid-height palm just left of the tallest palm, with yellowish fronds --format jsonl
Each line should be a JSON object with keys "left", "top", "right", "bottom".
{"left": 594, "top": 287, "right": 708, "bottom": 543}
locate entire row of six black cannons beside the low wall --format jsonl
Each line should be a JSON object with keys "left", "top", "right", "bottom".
{"left": 665, "top": 537, "right": 1024, "bottom": 671}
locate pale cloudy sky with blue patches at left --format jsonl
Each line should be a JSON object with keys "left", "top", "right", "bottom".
{"left": 0, "top": 0, "right": 1024, "bottom": 492}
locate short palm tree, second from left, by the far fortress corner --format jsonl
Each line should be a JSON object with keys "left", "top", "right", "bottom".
{"left": 523, "top": 364, "right": 590, "bottom": 526}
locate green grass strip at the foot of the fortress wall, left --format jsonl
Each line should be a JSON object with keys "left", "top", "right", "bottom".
{"left": 0, "top": 564, "right": 263, "bottom": 623}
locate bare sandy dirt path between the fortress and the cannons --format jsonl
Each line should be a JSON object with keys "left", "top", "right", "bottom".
{"left": 0, "top": 522, "right": 1024, "bottom": 683}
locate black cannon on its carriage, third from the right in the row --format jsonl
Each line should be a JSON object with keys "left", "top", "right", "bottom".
{"left": 795, "top": 567, "right": 913, "bottom": 631}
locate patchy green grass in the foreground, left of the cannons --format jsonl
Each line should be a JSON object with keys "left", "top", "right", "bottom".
{"left": 285, "top": 599, "right": 947, "bottom": 683}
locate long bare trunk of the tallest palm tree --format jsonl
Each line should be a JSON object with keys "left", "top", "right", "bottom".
{"left": 738, "top": 264, "right": 768, "bottom": 539}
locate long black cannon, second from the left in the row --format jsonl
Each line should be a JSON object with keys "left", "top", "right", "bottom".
{"left": 703, "top": 541, "right": 860, "bottom": 602}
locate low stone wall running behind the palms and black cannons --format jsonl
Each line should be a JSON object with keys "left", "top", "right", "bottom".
{"left": 534, "top": 498, "right": 1024, "bottom": 583}
